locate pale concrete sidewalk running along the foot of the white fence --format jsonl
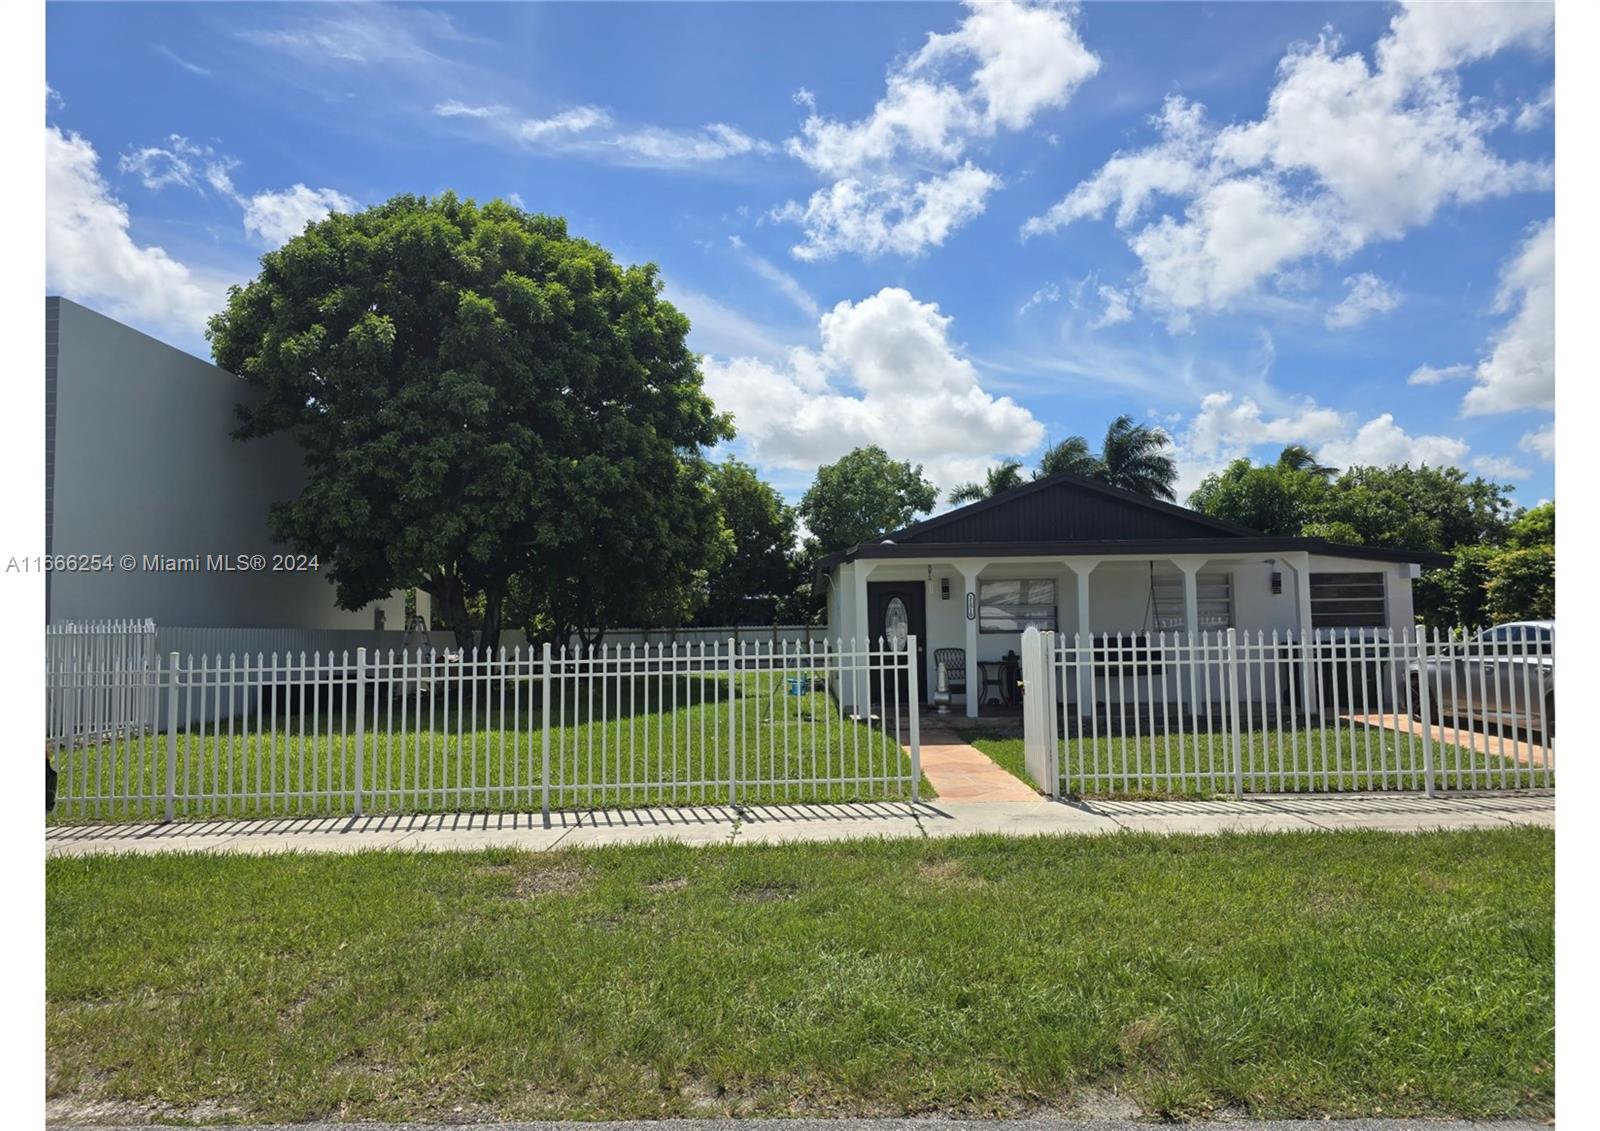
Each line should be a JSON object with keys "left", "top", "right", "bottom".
{"left": 45, "top": 790, "right": 1555, "bottom": 856}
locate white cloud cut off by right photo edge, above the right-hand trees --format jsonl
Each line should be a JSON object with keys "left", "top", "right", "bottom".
{"left": 1461, "top": 219, "right": 1555, "bottom": 416}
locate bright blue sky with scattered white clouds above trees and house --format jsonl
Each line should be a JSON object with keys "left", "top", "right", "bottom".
{"left": 46, "top": 3, "right": 1555, "bottom": 504}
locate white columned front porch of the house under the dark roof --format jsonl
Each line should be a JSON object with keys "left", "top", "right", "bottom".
{"left": 830, "top": 546, "right": 1411, "bottom": 729}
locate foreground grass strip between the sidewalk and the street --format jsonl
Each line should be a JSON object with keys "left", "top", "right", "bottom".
{"left": 46, "top": 829, "right": 1554, "bottom": 1121}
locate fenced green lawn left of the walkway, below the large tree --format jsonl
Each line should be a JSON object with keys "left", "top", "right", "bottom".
{"left": 53, "top": 672, "right": 934, "bottom": 821}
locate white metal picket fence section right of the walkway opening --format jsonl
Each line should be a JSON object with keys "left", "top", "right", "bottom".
{"left": 1022, "top": 629, "right": 1555, "bottom": 797}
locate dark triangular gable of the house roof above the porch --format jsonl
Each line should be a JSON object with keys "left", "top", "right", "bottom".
{"left": 880, "top": 472, "right": 1259, "bottom": 544}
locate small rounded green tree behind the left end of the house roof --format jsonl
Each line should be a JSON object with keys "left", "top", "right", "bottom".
{"left": 797, "top": 445, "right": 939, "bottom": 555}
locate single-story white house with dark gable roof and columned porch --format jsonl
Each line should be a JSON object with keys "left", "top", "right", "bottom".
{"left": 818, "top": 472, "right": 1450, "bottom": 717}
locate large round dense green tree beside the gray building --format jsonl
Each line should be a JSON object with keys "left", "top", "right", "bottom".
{"left": 206, "top": 192, "right": 730, "bottom": 646}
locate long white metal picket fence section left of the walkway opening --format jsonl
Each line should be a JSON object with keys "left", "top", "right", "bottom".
{"left": 48, "top": 640, "right": 920, "bottom": 821}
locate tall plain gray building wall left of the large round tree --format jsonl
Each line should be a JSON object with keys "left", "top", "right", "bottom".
{"left": 48, "top": 299, "right": 405, "bottom": 629}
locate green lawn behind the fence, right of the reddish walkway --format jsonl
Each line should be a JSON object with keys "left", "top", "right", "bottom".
{"left": 958, "top": 726, "right": 1555, "bottom": 798}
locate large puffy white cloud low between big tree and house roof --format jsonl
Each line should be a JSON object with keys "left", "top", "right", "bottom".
{"left": 702, "top": 288, "right": 1045, "bottom": 488}
